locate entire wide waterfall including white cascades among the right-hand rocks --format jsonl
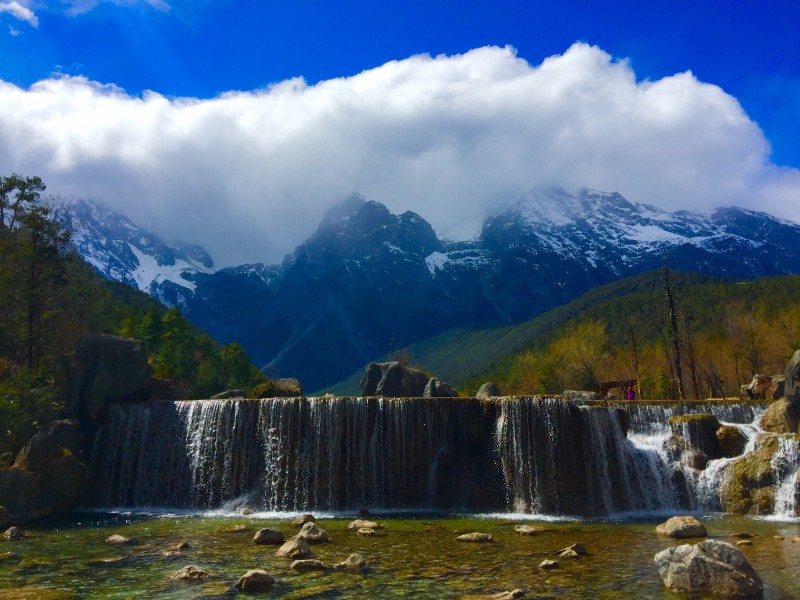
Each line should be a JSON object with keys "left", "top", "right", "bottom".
{"left": 92, "top": 398, "right": 800, "bottom": 516}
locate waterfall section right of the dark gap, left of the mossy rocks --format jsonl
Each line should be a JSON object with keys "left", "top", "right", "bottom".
{"left": 497, "top": 398, "right": 678, "bottom": 516}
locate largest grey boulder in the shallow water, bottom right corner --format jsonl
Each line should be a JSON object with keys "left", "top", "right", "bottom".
{"left": 654, "top": 540, "right": 764, "bottom": 598}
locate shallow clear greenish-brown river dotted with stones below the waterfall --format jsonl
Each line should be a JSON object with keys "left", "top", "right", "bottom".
{"left": 0, "top": 513, "right": 800, "bottom": 600}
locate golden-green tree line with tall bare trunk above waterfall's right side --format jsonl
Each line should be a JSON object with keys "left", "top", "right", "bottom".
{"left": 492, "top": 268, "right": 800, "bottom": 399}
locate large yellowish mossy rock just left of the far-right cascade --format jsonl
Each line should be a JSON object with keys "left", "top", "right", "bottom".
{"left": 719, "top": 435, "right": 780, "bottom": 515}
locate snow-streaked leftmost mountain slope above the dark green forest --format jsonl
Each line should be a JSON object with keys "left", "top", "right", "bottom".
{"left": 58, "top": 200, "right": 216, "bottom": 305}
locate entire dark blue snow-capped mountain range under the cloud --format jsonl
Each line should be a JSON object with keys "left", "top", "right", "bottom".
{"left": 61, "top": 188, "right": 800, "bottom": 390}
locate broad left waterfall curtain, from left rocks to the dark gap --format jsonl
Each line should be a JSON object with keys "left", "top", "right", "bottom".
{"left": 92, "top": 398, "right": 491, "bottom": 511}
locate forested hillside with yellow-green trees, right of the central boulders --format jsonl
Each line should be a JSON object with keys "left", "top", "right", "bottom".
{"left": 324, "top": 271, "right": 800, "bottom": 397}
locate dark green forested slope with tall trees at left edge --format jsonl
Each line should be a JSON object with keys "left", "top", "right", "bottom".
{"left": 0, "top": 175, "right": 264, "bottom": 463}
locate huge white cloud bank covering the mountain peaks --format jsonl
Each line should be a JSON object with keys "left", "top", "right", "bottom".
{"left": 0, "top": 44, "right": 800, "bottom": 263}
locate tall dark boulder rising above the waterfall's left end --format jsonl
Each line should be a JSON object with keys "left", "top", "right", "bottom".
{"left": 58, "top": 335, "right": 151, "bottom": 425}
